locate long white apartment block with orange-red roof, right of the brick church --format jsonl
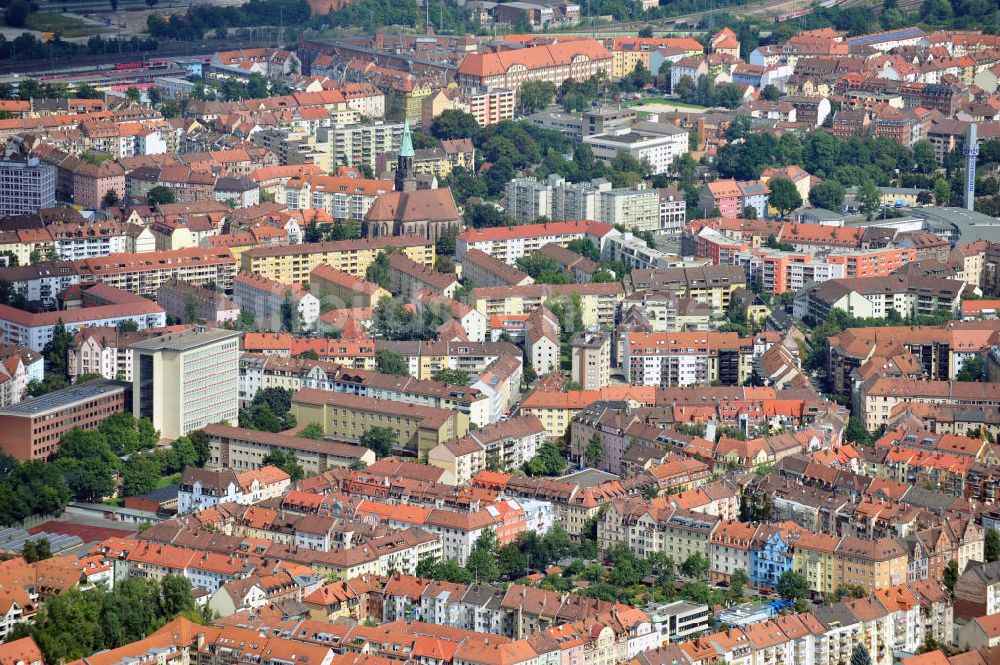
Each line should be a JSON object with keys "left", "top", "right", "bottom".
{"left": 455, "top": 220, "right": 615, "bottom": 265}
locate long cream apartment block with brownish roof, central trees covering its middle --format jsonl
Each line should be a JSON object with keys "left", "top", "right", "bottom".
{"left": 472, "top": 282, "right": 625, "bottom": 327}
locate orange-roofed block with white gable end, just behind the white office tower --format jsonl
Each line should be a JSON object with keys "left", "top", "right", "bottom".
{"left": 233, "top": 272, "right": 320, "bottom": 332}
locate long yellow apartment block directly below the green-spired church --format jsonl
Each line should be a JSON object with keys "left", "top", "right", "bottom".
{"left": 240, "top": 236, "right": 435, "bottom": 284}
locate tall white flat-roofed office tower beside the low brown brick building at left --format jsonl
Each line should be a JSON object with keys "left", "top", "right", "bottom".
{"left": 131, "top": 327, "right": 240, "bottom": 440}
